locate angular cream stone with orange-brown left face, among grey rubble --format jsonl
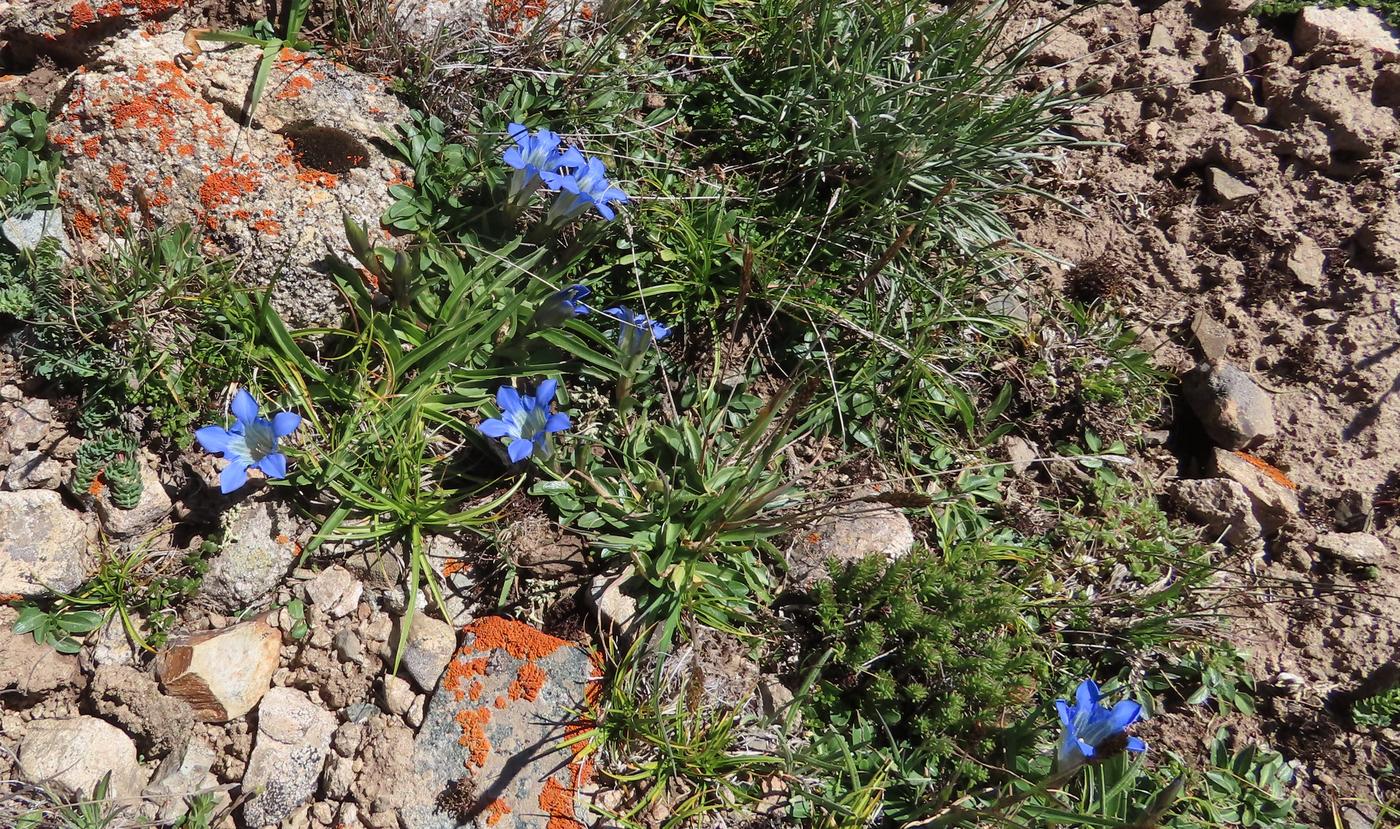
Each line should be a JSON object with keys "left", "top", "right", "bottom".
{"left": 155, "top": 619, "right": 281, "bottom": 723}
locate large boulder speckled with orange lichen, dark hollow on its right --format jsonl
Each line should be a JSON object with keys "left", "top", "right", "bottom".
{"left": 50, "top": 31, "right": 412, "bottom": 325}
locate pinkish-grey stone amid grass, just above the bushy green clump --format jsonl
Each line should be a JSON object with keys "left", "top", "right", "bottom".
{"left": 788, "top": 493, "right": 914, "bottom": 590}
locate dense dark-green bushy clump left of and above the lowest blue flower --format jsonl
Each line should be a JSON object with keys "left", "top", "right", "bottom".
{"left": 806, "top": 550, "right": 1047, "bottom": 812}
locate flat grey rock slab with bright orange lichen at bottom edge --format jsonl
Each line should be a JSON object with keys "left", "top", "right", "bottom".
{"left": 400, "top": 616, "right": 599, "bottom": 829}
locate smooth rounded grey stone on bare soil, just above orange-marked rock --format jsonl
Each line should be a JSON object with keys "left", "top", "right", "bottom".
{"left": 1182, "top": 361, "right": 1278, "bottom": 450}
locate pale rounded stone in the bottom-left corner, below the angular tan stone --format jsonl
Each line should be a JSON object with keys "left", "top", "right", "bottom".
{"left": 20, "top": 717, "right": 146, "bottom": 798}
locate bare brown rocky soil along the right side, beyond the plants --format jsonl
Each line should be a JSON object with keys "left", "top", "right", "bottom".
{"left": 1016, "top": 0, "right": 1400, "bottom": 825}
